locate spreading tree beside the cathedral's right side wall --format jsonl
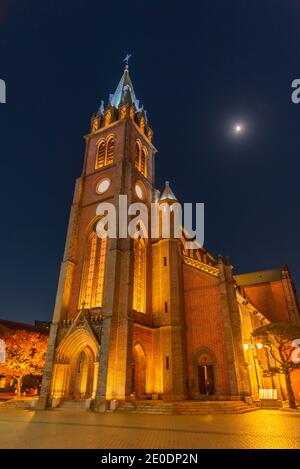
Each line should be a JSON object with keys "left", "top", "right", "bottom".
{"left": 252, "top": 321, "right": 300, "bottom": 409}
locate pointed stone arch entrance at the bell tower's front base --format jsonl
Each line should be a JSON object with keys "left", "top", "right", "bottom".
{"left": 51, "top": 327, "right": 99, "bottom": 399}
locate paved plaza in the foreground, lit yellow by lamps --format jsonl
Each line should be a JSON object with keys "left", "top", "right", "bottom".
{"left": 0, "top": 409, "right": 300, "bottom": 449}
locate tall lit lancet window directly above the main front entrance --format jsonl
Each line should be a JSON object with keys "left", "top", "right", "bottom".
{"left": 79, "top": 232, "right": 107, "bottom": 308}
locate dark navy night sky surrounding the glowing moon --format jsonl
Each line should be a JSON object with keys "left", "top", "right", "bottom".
{"left": 0, "top": 0, "right": 300, "bottom": 322}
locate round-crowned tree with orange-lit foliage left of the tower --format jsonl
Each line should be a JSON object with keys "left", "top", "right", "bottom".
{"left": 0, "top": 330, "right": 48, "bottom": 397}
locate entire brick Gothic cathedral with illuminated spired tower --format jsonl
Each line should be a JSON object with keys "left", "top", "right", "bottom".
{"left": 38, "top": 64, "right": 300, "bottom": 412}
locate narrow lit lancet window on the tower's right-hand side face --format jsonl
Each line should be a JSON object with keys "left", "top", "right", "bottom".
{"left": 133, "top": 238, "right": 147, "bottom": 313}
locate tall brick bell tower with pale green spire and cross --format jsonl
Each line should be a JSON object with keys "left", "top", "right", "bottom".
{"left": 39, "top": 60, "right": 157, "bottom": 410}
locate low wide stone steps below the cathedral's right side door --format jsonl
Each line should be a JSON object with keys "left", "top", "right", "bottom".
{"left": 115, "top": 401, "right": 258, "bottom": 415}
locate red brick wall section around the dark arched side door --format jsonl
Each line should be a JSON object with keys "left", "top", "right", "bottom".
{"left": 183, "top": 265, "right": 230, "bottom": 395}
